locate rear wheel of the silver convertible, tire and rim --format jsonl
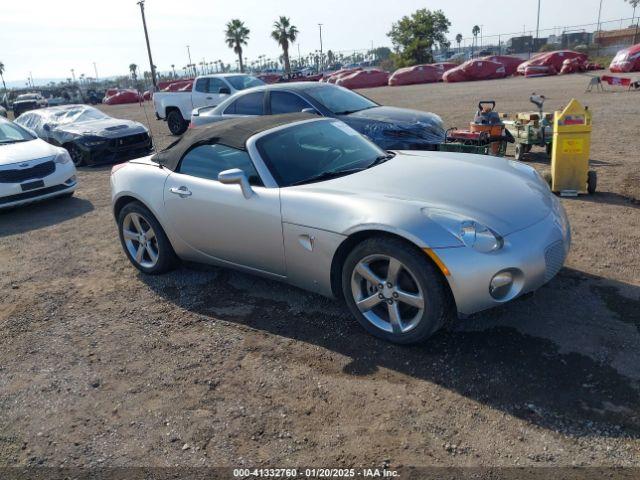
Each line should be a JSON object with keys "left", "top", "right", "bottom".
{"left": 118, "top": 202, "right": 176, "bottom": 275}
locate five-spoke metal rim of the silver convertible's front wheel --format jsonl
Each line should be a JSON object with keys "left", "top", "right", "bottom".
{"left": 351, "top": 255, "right": 425, "bottom": 334}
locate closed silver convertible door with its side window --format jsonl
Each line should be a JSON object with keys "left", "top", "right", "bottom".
{"left": 164, "top": 144, "right": 285, "bottom": 276}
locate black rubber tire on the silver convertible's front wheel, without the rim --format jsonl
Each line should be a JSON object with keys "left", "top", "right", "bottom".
{"left": 342, "top": 236, "right": 455, "bottom": 344}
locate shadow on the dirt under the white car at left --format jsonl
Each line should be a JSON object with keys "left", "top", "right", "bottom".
{"left": 0, "top": 197, "right": 94, "bottom": 238}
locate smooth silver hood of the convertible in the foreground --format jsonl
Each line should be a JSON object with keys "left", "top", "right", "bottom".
{"left": 292, "top": 151, "right": 553, "bottom": 236}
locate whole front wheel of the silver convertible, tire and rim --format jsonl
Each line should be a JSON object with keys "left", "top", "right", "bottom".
{"left": 342, "top": 237, "right": 449, "bottom": 344}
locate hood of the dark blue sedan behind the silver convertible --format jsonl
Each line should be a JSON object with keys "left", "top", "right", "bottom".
{"left": 339, "top": 106, "right": 445, "bottom": 144}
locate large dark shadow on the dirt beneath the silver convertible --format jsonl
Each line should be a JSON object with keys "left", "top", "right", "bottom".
{"left": 140, "top": 267, "right": 640, "bottom": 438}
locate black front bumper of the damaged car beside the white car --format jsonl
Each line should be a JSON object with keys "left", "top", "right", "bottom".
{"left": 75, "top": 134, "right": 153, "bottom": 165}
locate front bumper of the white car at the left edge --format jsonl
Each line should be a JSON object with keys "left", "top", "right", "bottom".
{"left": 0, "top": 162, "right": 78, "bottom": 209}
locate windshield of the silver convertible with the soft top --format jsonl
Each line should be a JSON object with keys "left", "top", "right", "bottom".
{"left": 256, "top": 120, "right": 388, "bottom": 187}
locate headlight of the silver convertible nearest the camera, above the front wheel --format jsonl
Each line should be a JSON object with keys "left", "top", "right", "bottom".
{"left": 423, "top": 208, "right": 504, "bottom": 253}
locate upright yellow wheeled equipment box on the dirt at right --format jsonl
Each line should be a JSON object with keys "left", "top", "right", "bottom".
{"left": 551, "top": 99, "right": 597, "bottom": 196}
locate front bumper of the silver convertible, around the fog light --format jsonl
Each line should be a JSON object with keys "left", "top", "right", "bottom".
{"left": 434, "top": 207, "right": 571, "bottom": 315}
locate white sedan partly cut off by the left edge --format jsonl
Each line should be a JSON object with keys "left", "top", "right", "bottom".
{"left": 0, "top": 118, "right": 77, "bottom": 209}
